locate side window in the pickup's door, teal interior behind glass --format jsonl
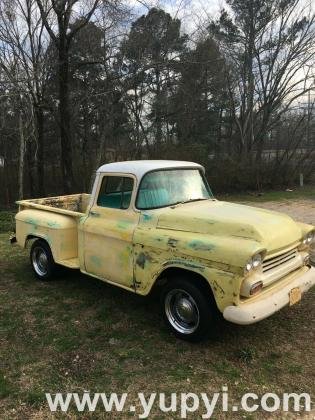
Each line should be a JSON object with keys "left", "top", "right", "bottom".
{"left": 97, "top": 176, "right": 133, "bottom": 209}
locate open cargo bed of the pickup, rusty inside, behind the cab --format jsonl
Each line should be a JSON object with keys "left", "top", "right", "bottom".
{"left": 17, "top": 194, "right": 90, "bottom": 217}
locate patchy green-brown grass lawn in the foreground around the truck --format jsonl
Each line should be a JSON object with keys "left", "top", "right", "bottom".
{"left": 0, "top": 192, "right": 315, "bottom": 419}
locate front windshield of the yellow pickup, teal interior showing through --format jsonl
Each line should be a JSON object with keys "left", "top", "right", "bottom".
{"left": 136, "top": 169, "right": 213, "bottom": 210}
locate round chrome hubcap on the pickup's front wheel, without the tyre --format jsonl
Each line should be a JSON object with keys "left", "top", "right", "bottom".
{"left": 165, "top": 289, "right": 199, "bottom": 334}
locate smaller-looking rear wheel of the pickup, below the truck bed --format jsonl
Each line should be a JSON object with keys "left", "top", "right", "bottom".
{"left": 30, "top": 239, "right": 56, "bottom": 280}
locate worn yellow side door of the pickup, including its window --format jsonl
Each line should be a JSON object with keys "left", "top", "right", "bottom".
{"left": 84, "top": 174, "right": 139, "bottom": 288}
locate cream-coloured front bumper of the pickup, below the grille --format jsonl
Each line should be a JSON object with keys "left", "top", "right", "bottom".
{"left": 223, "top": 267, "right": 315, "bottom": 325}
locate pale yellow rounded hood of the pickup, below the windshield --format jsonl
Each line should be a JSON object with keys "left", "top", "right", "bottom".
{"left": 157, "top": 200, "right": 302, "bottom": 252}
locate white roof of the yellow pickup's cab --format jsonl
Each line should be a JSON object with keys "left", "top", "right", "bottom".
{"left": 97, "top": 160, "right": 204, "bottom": 180}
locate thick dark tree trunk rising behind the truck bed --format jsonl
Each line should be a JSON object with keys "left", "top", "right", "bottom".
{"left": 58, "top": 46, "right": 74, "bottom": 194}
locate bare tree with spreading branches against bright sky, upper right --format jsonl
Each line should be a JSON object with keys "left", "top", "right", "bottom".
{"left": 210, "top": 0, "right": 315, "bottom": 163}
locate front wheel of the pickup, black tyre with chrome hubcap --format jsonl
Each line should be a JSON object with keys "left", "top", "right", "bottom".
{"left": 161, "top": 277, "right": 215, "bottom": 342}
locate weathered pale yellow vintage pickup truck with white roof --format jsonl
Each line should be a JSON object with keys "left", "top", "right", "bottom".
{"left": 13, "top": 160, "right": 315, "bottom": 341}
